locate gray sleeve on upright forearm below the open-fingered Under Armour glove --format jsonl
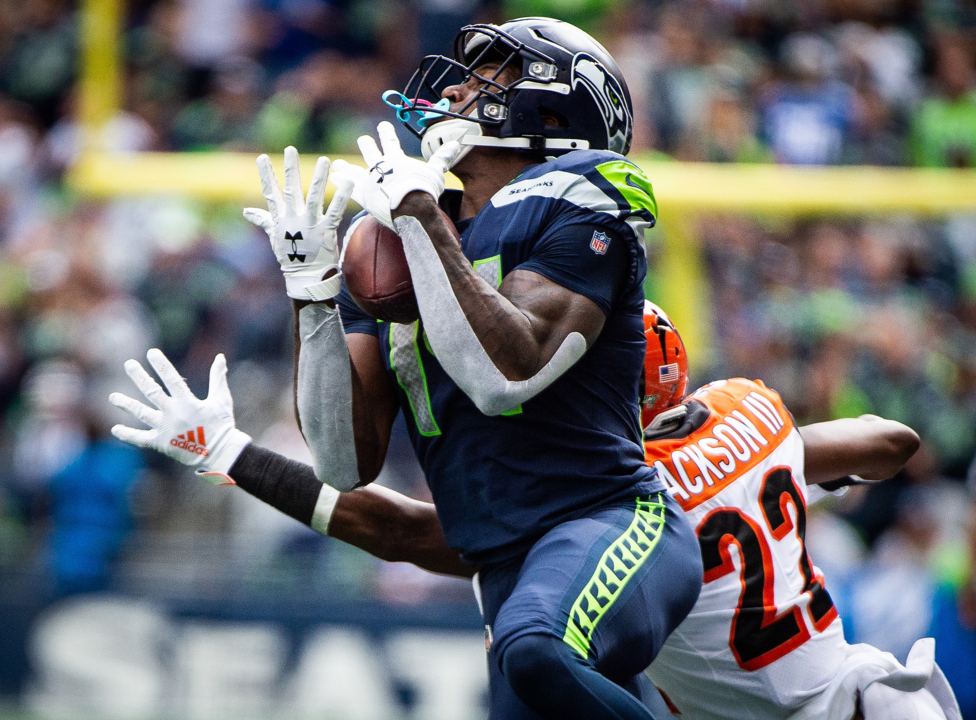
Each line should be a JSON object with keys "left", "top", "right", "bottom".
{"left": 296, "top": 303, "right": 359, "bottom": 492}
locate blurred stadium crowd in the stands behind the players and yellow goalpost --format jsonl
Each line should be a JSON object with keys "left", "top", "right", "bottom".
{"left": 0, "top": 0, "right": 976, "bottom": 717}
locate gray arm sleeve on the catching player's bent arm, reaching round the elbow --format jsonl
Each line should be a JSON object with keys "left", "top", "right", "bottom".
{"left": 394, "top": 216, "right": 586, "bottom": 415}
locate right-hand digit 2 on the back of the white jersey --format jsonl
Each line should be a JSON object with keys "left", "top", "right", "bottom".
{"left": 759, "top": 467, "right": 837, "bottom": 632}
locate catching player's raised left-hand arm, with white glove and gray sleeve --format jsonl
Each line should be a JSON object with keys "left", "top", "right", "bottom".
{"left": 244, "top": 147, "right": 395, "bottom": 491}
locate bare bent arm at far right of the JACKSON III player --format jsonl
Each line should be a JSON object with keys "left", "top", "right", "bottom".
{"left": 800, "top": 415, "right": 920, "bottom": 485}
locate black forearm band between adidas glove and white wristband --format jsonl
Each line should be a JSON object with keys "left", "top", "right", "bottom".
{"left": 229, "top": 443, "right": 322, "bottom": 525}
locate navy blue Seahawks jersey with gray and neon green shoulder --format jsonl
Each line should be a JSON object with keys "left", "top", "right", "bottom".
{"left": 338, "top": 151, "right": 663, "bottom": 563}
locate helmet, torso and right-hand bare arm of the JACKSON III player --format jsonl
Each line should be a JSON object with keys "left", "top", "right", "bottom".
{"left": 628, "top": 307, "right": 961, "bottom": 720}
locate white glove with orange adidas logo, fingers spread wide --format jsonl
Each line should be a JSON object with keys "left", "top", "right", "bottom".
{"left": 108, "top": 348, "right": 251, "bottom": 485}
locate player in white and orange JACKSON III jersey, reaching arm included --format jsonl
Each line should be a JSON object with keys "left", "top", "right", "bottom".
{"left": 113, "top": 303, "right": 960, "bottom": 720}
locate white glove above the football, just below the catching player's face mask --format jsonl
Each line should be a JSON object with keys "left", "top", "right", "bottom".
{"left": 340, "top": 122, "right": 461, "bottom": 230}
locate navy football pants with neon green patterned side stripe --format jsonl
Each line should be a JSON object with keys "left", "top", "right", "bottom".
{"left": 479, "top": 492, "right": 702, "bottom": 720}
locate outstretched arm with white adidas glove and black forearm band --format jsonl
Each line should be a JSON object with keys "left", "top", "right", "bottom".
{"left": 109, "top": 349, "right": 474, "bottom": 577}
